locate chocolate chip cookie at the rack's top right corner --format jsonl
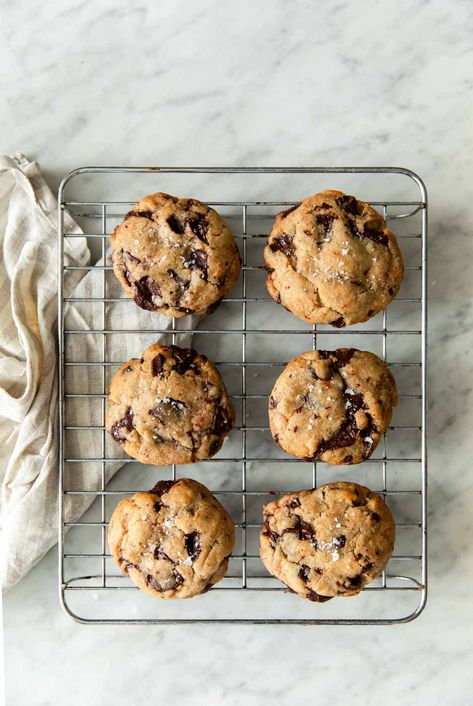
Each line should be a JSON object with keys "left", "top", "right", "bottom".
{"left": 264, "top": 190, "right": 404, "bottom": 327}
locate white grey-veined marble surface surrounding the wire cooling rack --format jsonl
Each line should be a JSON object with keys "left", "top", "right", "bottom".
{"left": 0, "top": 0, "right": 473, "bottom": 706}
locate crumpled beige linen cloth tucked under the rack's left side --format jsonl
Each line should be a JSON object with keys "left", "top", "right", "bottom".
{"left": 0, "top": 154, "right": 196, "bottom": 589}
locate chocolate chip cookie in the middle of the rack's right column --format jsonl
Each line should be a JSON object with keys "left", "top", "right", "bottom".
{"left": 268, "top": 348, "right": 397, "bottom": 465}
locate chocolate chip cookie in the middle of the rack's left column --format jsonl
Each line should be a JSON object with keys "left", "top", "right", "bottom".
{"left": 106, "top": 343, "right": 235, "bottom": 465}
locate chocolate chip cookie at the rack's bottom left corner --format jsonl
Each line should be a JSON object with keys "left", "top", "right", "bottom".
{"left": 108, "top": 478, "right": 235, "bottom": 599}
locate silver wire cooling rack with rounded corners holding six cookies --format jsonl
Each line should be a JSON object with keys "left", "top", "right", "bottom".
{"left": 58, "top": 167, "right": 427, "bottom": 624}
